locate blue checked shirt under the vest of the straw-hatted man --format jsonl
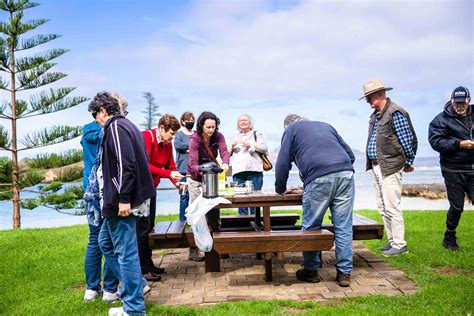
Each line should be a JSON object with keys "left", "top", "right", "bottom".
{"left": 367, "top": 111, "right": 415, "bottom": 165}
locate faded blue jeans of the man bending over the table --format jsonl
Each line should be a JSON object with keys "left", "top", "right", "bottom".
{"left": 302, "top": 171, "right": 355, "bottom": 273}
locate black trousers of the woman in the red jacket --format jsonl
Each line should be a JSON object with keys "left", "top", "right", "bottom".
{"left": 137, "top": 197, "right": 156, "bottom": 274}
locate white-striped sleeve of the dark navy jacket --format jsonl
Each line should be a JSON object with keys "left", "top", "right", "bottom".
{"left": 109, "top": 120, "right": 137, "bottom": 203}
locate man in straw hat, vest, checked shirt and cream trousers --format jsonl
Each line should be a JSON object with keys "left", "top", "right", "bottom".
{"left": 359, "top": 80, "right": 418, "bottom": 257}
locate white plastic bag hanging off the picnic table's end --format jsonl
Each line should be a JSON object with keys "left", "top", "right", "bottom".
{"left": 185, "top": 194, "right": 230, "bottom": 252}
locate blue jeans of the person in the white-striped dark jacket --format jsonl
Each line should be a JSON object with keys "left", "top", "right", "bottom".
{"left": 99, "top": 215, "right": 146, "bottom": 315}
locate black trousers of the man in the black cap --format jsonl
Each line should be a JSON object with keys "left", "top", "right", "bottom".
{"left": 441, "top": 171, "right": 474, "bottom": 232}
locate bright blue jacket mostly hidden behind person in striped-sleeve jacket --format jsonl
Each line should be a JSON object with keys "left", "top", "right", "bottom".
{"left": 81, "top": 121, "right": 100, "bottom": 191}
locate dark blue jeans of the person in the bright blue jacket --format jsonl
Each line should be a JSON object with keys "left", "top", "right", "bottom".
{"left": 84, "top": 220, "right": 119, "bottom": 293}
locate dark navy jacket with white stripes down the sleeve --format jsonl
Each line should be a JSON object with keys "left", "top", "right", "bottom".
{"left": 102, "top": 116, "right": 156, "bottom": 217}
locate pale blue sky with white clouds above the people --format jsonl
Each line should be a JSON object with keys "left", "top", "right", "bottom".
{"left": 0, "top": 0, "right": 474, "bottom": 159}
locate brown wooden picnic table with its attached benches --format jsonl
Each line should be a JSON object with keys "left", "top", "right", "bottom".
{"left": 149, "top": 192, "right": 383, "bottom": 281}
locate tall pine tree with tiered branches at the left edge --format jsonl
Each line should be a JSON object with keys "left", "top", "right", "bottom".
{"left": 0, "top": 0, "right": 87, "bottom": 229}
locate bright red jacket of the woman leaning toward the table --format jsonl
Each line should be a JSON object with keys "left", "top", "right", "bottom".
{"left": 142, "top": 128, "right": 177, "bottom": 187}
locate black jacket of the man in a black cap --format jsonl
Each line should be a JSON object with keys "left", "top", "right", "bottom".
{"left": 428, "top": 102, "right": 474, "bottom": 171}
